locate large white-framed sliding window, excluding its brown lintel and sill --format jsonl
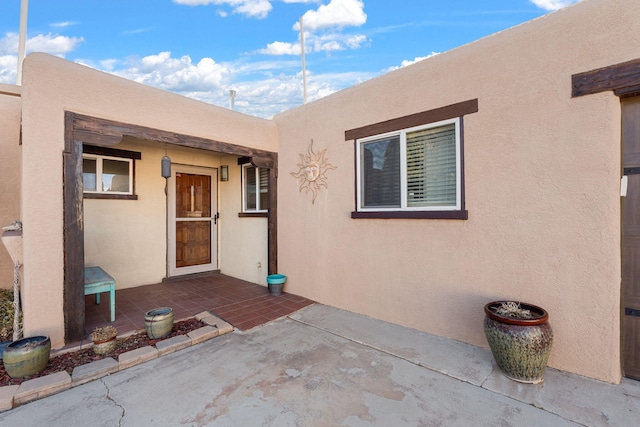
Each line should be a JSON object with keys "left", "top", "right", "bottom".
{"left": 356, "top": 118, "right": 462, "bottom": 212}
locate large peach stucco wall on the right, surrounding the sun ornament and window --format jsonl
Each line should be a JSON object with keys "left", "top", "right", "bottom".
{"left": 275, "top": 0, "right": 640, "bottom": 382}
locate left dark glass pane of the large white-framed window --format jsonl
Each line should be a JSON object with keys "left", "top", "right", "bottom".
{"left": 360, "top": 136, "right": 400, "bottom": 208}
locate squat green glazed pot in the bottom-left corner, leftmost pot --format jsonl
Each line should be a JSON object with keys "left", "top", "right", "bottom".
{"left": 2, "top": 335, "right": 51, "bottom": 378}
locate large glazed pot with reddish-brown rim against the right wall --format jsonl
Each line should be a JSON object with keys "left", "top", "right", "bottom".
{"left": 484, "top": 301, "right": 553, "bottom": 384}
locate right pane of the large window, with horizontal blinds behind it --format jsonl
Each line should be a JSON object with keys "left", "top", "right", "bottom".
{"left": 407, "top": 124, "right": 457, "bottom": 207}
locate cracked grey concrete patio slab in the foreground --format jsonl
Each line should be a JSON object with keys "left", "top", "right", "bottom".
{"left": 0, "top": 304, "right": 640, "bottom": 427}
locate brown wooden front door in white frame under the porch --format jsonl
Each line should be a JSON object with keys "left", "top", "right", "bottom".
{"left": 168, "top": 165, "right": 217, "bottom": 276}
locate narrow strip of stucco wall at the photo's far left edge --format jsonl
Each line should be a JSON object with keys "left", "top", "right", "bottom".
{"left": 0, "top": 88, "right": 20, "bottom": 289}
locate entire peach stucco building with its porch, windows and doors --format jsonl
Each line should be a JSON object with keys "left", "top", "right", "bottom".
{"left": 0, "top": 0, "right": 640, "bottom": 382}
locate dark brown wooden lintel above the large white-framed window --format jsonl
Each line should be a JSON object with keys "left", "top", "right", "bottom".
{"left": 344, "top": 99, "right": 478, "bottom": 141}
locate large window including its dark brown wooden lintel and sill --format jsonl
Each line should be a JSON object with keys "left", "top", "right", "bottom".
{"left": 346, "top": 100, "right": 477, "bottom": 219}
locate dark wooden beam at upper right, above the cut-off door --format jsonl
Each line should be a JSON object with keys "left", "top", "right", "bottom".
{"left": 571, "top": 59, "right": 640, "bottom": 98}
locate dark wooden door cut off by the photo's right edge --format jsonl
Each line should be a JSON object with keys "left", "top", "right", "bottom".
{"left": 622, "top": 97, "right": 640, "bottom": 379}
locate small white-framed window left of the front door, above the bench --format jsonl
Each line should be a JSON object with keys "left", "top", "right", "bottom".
{"left": 82, "top": 154, "right": 133, "bottom": 195}
